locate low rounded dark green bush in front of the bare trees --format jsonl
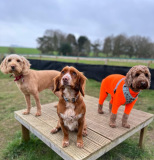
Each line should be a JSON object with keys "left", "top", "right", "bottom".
{"left": 59, "top": 43, "right": 72, "bottom": 56}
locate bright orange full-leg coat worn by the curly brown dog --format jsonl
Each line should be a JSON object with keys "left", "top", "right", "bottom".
{"left": 99, "top": 74, "right": 139, "bottom": 114}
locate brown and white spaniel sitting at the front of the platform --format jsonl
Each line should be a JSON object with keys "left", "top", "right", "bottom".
{"left": 51, "top": 66, "right": 87, "bottom": 148}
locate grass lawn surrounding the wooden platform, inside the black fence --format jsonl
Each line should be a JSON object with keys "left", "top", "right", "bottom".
{"left": 0, "top": 72, "right": 154, "bottom": 160}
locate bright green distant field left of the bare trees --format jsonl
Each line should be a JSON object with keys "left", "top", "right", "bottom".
{"left": 0, "top": 47, "right": 40, "bottom": 54}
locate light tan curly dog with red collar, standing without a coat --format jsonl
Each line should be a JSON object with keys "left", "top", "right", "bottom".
{"left": 0, "top": 54, "right": 60, "bottom": 116}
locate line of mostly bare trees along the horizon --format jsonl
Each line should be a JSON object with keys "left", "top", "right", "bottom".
{"left": 37, "top": 30, "right": 154, "bottom": 58}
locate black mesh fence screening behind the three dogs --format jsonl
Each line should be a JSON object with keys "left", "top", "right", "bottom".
{"left": 29, "top": 59, "right": 154, "bottom": 89}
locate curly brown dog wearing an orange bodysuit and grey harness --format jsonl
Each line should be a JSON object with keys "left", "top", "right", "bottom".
{"left": 98, "top": 65, "right": 151, "bottom": 128}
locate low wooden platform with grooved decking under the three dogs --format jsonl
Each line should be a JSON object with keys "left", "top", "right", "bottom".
{"left": 15, "top": 96, "right": 153, "bottom": 160}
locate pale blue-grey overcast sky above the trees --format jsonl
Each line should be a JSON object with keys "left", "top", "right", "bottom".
{"left": 0, "top": 0, "right": 154, "bottom": 47}
